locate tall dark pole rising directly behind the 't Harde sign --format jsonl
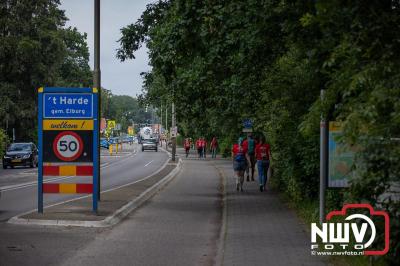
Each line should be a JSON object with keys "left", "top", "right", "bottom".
{"left": 93, "top": 0, "right": 101, "bottom": 200}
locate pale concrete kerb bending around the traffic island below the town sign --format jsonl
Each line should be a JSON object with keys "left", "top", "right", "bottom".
{"left": 7, "top": 157, "right": 182, "bottom": 227}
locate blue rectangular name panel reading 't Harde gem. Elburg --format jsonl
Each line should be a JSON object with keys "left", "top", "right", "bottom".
{"left": 43, "top": 93, "right": 93, "bottom": 118}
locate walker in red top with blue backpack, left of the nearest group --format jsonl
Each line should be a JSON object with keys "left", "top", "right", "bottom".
{"left": 232, "top": 138, "right": 247, "bottom": 191}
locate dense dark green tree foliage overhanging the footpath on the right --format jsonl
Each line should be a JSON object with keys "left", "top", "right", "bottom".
{"left": 117, "top": 0, "right": 400, "bottom": 262}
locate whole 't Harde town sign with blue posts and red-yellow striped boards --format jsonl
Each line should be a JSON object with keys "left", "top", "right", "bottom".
{"left": 38, "top": 88, "right": 99, "bottom": 213}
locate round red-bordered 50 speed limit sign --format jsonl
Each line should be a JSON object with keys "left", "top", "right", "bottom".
{"left": 53, "top": 131, "right": 83, "bottom": 162}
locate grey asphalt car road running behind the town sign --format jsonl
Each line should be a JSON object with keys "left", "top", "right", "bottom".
{"left": 0, "top": 144, "right": 168, "bottom": 222}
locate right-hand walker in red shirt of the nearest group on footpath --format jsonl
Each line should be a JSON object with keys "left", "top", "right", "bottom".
{"left": 255, "top": 136, "right": 271, "bottom": 191}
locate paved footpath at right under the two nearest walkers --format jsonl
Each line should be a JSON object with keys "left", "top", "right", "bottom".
{"left": 214, "top": 160, "right": 324, "bottom": 266}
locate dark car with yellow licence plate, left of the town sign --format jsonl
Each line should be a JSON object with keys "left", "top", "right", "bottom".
{"left": 3, "top": 142, "right": 39, "bottom": 169}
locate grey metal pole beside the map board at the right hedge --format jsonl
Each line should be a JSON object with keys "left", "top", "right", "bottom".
{"left": 319, "top": 90, "right": 328, "bottom": 224}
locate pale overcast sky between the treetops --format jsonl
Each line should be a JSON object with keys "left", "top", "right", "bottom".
{"left": 60, "top": 0, "right": 154, "bottom": 97}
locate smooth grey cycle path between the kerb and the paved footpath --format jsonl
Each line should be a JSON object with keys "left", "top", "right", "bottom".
{"left": 62, "top": 161, "right": 222, "bottom": 266}
